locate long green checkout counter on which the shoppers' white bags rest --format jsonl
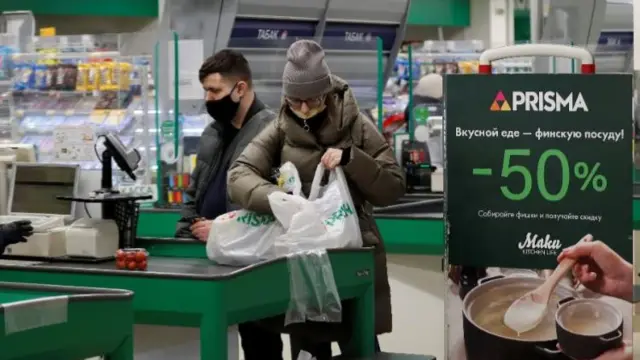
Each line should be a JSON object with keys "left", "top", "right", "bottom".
{"left": 0, "top": 249, "right": 374, "bottom": 360}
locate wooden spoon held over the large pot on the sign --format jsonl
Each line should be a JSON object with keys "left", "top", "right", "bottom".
{"left": 504, "top": 235, "right": 593, "bottom": 334}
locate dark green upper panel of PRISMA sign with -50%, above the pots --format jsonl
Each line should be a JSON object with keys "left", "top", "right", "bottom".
{"left": 445, "top": 74, "right": 633, "bottom": 268}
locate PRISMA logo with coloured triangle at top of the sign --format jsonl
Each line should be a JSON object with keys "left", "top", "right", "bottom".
{"left": 489, "top": 90, "right": 589, "bottom": 112}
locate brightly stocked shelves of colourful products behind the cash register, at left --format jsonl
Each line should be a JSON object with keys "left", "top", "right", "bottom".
{"left": 0, "top": 34, "right": 156, "bottom": 208}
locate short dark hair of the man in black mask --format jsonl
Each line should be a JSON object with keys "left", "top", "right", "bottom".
{"left": 198, "top": 49, "right": 251, "bottom": 86}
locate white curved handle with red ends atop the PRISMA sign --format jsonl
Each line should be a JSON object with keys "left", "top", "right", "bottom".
{"left": 478, "top": 44, "right": 596, "bottom": 75}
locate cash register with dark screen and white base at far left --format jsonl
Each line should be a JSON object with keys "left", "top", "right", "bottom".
{"left": 0, "top": 162, "right": 80, "bottom": 257}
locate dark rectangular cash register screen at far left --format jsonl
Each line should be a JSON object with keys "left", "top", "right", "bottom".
{"left": 8, "top": 163, "right": 80, "bottom": 218}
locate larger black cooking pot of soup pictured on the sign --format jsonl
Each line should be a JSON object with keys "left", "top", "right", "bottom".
{"left": 462, "top": 275, "right": 578, "bottom": 360}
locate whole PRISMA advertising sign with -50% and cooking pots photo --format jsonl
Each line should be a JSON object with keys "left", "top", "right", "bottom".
{"left": 445, "top": 74, "right": 633, "bottom": 360}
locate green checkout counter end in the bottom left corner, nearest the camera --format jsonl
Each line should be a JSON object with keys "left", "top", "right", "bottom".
{"left": 0, "top": 282, "right": 133, "bottom": 360}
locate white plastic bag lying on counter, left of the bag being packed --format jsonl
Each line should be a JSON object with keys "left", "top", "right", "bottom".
{"left": 207, "top": 210, "right": 284, "bottom": 265}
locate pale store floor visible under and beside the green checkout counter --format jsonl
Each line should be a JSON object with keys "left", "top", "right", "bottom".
{"left": 124, "top": 255, "right": 445, "bottom": 360}
